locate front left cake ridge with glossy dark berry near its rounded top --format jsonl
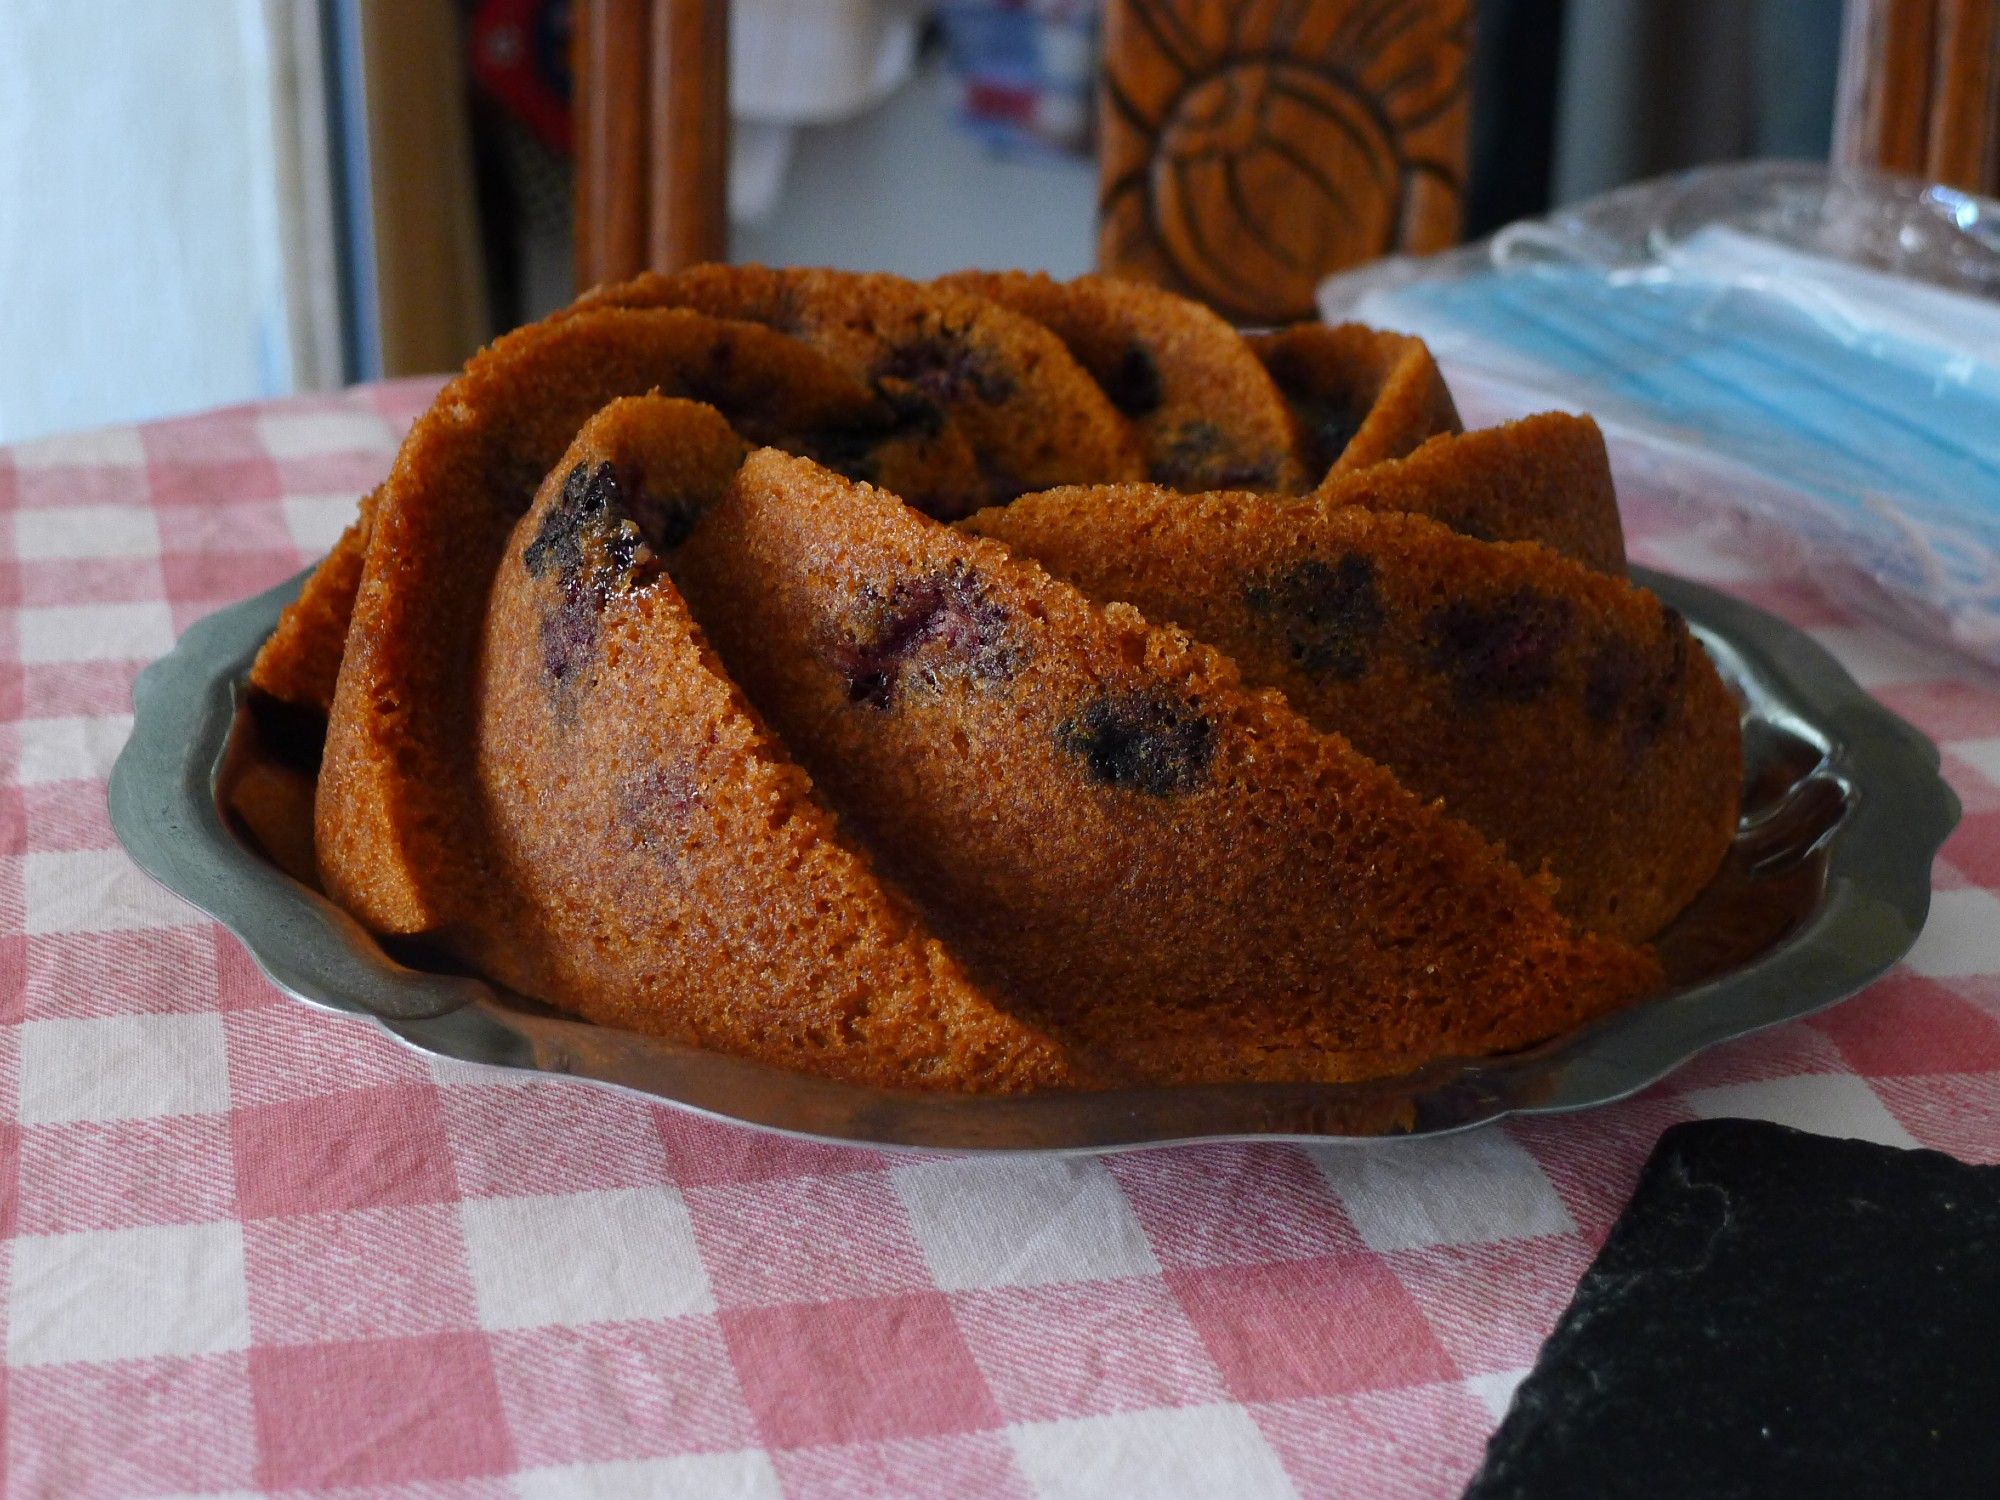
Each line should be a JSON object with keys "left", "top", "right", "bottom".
{"left": 464, "top": 396, "right": 1074, "bottom": 1092}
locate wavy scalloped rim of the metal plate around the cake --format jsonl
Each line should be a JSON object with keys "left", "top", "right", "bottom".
{"left": 108, "top": 568, "right": 1960, "bottom": 1154}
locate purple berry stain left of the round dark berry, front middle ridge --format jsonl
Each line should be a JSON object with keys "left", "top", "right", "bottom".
{"left": 832, "top": 564, "right": 1020, "bottom": 708}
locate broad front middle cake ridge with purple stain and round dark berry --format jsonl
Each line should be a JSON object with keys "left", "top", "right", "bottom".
{"left": 668, "top": 450, "right": 1658, "bottom": 1080}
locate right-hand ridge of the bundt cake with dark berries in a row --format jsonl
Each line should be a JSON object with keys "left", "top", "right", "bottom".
{"left": 962, "top": 490, "right": 1742, "bottom": 940}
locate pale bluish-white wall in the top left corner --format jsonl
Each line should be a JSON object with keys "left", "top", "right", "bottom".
{"left": 0, "top": 0, "right": 290, "bottom": 442}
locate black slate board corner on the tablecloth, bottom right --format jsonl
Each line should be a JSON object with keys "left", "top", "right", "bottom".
{"left": 1466, "top": 1120, "right": 2000, "bottom": 1500}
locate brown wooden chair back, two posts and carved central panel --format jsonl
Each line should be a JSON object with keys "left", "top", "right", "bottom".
{"left": 576, "top": 0, "right": 2000, "bottom": 324}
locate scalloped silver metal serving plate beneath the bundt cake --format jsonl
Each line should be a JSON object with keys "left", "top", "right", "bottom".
{"left": 110, "top": 570, "right": 1958, "bottom": 1152}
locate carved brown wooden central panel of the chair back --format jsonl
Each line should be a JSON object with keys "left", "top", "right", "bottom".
{"left": 1098, "top": 0, "right": 1472, "bottom": 322}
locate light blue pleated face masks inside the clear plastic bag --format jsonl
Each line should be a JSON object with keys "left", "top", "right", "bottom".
{"left": 1328, "top": 164, "right": 2000, "bottom": 662}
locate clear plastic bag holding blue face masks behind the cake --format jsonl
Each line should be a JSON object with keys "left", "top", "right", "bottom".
{"left": 1320, "top": 164, "right": 2000, "bottom": 666}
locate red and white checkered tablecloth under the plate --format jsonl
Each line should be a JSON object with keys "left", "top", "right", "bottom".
{"left": 0, "top": 384, "right": 2000, "bottom": 1500}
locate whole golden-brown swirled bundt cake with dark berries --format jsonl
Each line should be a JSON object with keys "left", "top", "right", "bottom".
{"left": 252, "top": 266, "right": 1740, "bottom": 1092}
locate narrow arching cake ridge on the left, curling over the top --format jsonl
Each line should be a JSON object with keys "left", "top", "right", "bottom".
{"left": 316, "top": 308, "right": 900, "bottom": 932}
